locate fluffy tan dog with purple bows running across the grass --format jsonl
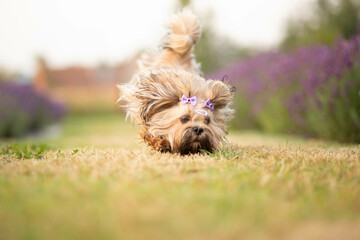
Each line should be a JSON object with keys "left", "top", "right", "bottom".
{"left": 117, "top": 9, "right": 234, "bottom": 155}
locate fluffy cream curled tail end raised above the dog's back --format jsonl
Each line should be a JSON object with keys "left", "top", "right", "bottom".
{"left": 162, "top": 9, "right": 201, "bottom": 55}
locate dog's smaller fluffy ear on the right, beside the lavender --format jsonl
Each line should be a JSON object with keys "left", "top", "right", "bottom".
{"left": 206, "top": 80, "right": 236, "bottom": 110}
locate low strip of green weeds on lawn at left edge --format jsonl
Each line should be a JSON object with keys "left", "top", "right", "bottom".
{"left": 0, "top": 143, "right": 49, "bottom": 159}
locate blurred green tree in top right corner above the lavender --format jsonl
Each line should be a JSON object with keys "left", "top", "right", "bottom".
{"left": 282, "top": 0, "right": 360, "bottom": 49}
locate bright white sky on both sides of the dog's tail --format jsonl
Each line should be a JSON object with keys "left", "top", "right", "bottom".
{"left": 0, "top": 0, "right": 313, "bottom": 74}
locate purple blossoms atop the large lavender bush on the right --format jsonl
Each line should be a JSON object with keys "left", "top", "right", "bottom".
{"left": 208, "top": 35, "right": 360, "bottom": 141}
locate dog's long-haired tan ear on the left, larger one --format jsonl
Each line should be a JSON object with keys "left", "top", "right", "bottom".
{"left": 135, "top": 72, "right": 180, "bottom": 123}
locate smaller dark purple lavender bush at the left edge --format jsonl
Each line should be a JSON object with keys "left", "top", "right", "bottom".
{"left": 0, "top": 82, "right": 65, "bottom": 137}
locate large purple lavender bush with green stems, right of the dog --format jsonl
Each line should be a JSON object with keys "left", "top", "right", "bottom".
{"left": 210, "top": 36, "right": 360, "bottom": 142}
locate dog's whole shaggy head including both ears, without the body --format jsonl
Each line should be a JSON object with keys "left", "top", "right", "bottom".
{"left": 122, "top": 69, "right": 233, "bottom": 155}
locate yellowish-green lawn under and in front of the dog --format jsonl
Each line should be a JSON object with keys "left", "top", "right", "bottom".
{"left": 0, "top": 114, "right": 360, "bottom": 239}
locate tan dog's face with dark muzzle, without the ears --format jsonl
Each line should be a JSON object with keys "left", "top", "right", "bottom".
{"left": 148, "top": 102, "right": 219, "bottom": 155}
